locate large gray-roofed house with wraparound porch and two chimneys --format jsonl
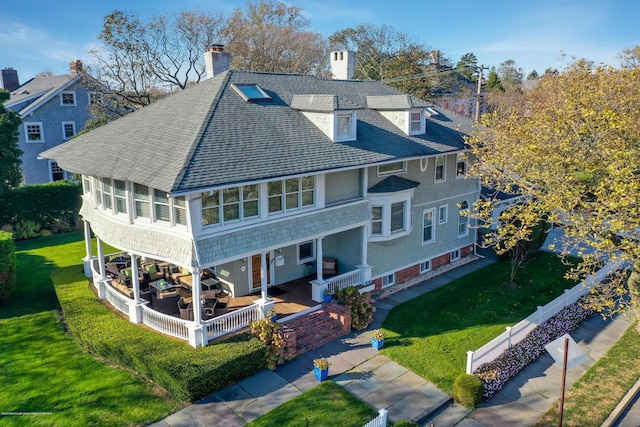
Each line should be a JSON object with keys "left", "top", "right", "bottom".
{"left": 41, "top": 48, "right": 479, "bottom": 346}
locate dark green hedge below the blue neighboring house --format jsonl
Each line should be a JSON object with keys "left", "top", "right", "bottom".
{"left": 0, "top": 181, "right": 82, "bottom": 239}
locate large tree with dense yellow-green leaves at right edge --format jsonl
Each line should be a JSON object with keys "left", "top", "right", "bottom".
{"left": 468, "top": 62, "right": 640, "bottom": 322}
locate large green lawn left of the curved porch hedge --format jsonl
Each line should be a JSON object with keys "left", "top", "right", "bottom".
{"left": 0, "top": 233, "right": 182, "bottom": 426}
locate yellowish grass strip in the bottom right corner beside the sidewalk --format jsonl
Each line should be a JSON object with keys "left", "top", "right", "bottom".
{"left": 535, "top": 324, "right": 640, "bottom": 427}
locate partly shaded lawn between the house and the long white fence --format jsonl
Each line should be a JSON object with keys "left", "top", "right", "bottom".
{"left": 382, "top": 252, "right": 575, "bottom": 393}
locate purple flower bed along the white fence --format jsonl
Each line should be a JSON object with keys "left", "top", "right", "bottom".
{"left": 473, "top": 297, "right": 594, "bottom": 399}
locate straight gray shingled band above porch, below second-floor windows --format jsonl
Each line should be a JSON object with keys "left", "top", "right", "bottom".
{"left": 196, "top": 200, "right": 371, "bottom": 265}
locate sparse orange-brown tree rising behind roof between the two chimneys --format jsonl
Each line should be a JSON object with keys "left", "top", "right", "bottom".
{"left": 223, "top": 0, "right": 328, "bottom": 76}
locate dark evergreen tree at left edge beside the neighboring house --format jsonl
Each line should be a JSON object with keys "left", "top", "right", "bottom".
{"left": 0, "top": 89, "right": 22, "bottom": 193}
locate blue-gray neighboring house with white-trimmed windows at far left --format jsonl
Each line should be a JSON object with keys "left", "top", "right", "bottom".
{"left": 2, "top": 60, "right": 97, "bottom": 184}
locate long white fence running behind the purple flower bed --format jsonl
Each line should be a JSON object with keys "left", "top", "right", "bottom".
{"left": 466, "top": 262, "right": 627, "bottom": 374}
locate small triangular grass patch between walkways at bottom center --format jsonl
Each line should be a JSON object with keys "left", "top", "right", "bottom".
{"left": 247, "top": 381, "right": 378, "bottom": 427}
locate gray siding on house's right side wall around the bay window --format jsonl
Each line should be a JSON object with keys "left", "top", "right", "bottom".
{"left": 368, "top": 154, "right": 478, "bottom": 278}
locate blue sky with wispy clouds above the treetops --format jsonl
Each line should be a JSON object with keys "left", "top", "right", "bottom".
{"left": 0, "top": 0, "right": 640, "bottom": 82}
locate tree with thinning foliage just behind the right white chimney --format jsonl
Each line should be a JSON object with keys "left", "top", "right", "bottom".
{"left": 329, "top": 24, "right": 435, "bottom": 98}
